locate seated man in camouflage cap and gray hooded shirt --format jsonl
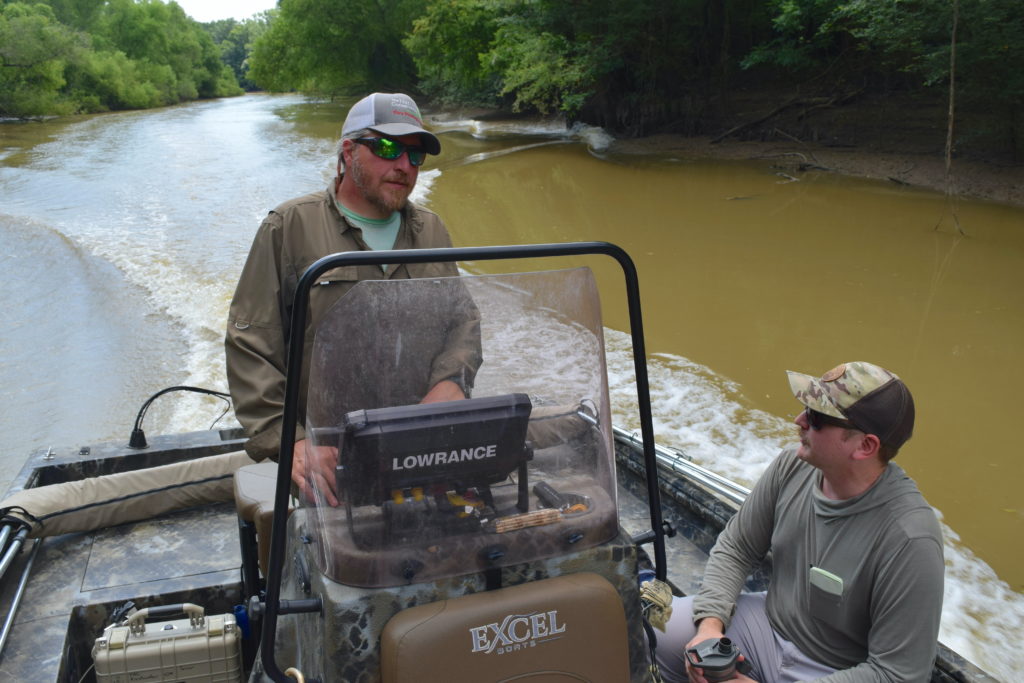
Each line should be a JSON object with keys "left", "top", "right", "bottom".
{"left": 657, "top": 361, "right": 944, "bottom": 683}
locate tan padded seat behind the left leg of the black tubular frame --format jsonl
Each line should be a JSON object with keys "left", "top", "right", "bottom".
{"left": 234, "top": 460, "right": 291, "bottom": 595}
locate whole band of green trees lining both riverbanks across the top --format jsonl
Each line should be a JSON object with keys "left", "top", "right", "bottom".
{"left": 0, "top": 0, "right": 1024, "bottom": 158}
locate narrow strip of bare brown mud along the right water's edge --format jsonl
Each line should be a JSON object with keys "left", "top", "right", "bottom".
{"left": 609, "top": 134, "right": 1024, "bottom": 207}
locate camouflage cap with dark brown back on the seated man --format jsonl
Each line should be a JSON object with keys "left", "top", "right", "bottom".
{"left": 786, "top": 360, "right": 914, "bottom": 449}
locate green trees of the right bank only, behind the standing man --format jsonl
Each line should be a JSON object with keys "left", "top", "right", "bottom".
{"left": 241, "top": 0, "right": 1024, "bottom": 153}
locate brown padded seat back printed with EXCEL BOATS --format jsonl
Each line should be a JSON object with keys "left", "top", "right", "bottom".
{"left": 381, "top": 572, "right": 630, "bottom": 683}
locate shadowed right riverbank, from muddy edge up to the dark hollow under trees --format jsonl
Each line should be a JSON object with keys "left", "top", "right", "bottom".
{"left": 598, "top": 87, "right": 1024, "bottom": 206}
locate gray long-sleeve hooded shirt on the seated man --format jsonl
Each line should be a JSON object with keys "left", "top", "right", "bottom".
{"left": 693, "top": 451, "right": 944, "bottom": 683}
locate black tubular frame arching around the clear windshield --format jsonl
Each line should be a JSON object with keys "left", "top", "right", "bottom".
{"left": 260, "top": 242, "right": 666, "bottom": 683}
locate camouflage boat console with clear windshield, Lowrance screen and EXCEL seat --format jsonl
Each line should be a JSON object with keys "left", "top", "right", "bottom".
{"left": 257, "top": 268, "right": 647, "bottom": 682}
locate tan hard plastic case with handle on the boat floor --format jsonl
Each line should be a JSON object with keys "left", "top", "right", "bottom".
{"left": 92, "top": 603, "right": 242, "bottom": 683}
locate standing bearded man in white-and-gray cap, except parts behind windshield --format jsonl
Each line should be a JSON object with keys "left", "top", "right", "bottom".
{"left": 224, "top": 92, "right": 480, "bottom": 505}
